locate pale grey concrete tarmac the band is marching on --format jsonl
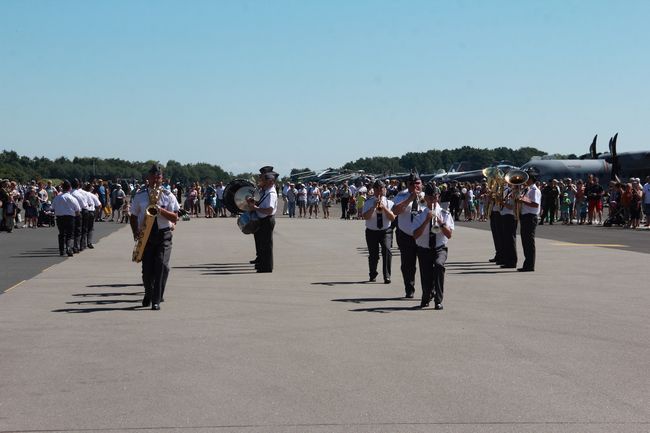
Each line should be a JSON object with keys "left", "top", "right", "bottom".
{"left": 0, "top": 214, "right": 650, "bottom": 433}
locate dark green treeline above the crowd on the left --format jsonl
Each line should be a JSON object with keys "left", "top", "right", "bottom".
{"left": 0, "top": 150, "right": 243, "bottom": 183}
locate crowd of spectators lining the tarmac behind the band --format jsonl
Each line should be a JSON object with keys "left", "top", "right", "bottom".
{"left": 0, "top": 175, "right": 650, "bottom": 232}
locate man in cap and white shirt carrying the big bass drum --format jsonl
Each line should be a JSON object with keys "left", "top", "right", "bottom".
{"left": 248, "top": 167, "right": 278, "bottom": 273}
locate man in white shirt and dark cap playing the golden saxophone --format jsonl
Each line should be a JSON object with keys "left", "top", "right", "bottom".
{"left": 130, "top": 164, "right": 180, "bottom": 310}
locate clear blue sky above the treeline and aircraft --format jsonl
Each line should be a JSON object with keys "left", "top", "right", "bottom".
{"left": 0, "top": 0, "right": 650, "bottom": 174}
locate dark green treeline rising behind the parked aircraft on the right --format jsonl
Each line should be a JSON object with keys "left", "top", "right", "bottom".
{"left": 342, "top": 146, "right": 576, "bottom": 173}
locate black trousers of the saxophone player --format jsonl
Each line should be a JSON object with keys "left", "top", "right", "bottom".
{"left": 142, "top": 229, "right": 172, "bottom": 304}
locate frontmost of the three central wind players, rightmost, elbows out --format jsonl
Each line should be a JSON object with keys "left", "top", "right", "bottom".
{"left": 412, "top": 184, "right": 454, "bottom": 310}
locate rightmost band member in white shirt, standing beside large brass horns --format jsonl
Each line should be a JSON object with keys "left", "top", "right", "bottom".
{"left": 517, "top": 170, "right": 542, "bottom": 272}
